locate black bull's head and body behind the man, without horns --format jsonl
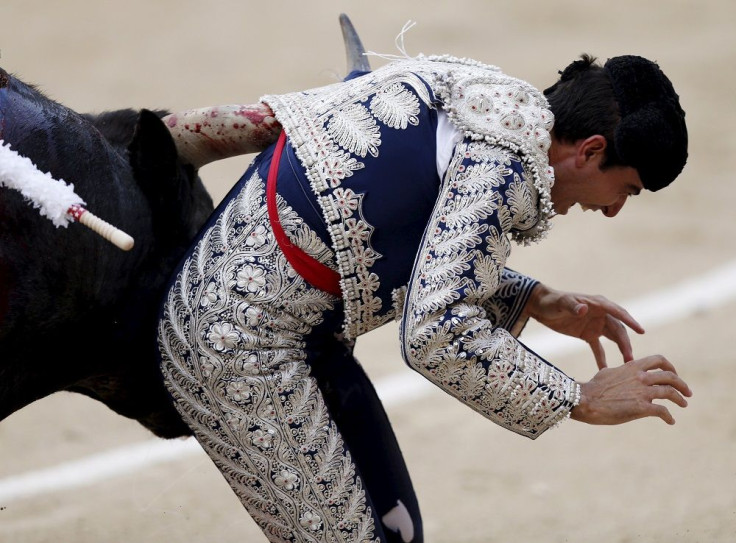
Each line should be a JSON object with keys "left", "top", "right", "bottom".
{"left": 0, "top": 69, "right": 212, "bottom": 437}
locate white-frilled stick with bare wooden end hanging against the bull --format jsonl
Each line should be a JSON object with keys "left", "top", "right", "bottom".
{"left": 0, "top": 140, "right": 134, "bottom": 251}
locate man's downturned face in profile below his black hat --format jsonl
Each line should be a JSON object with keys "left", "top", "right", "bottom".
{"left": 552, "top": 167, "right": 644, "bottom": 217}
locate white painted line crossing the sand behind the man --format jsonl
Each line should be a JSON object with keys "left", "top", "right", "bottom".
{"left": 0, "top": 261, "right": 736, "bottom": 505}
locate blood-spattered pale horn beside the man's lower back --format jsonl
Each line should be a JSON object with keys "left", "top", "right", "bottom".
{"left": 163, "top": 103, "right": 281, "bottom": 168}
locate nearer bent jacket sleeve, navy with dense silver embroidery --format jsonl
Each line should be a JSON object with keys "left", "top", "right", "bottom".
{"left": 401, "top": 142, "right": 579, "bottom": 439}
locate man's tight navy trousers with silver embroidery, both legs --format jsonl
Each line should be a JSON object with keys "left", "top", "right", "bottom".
{"left": 159, "top": 160, "right": 422, "bottom": 543}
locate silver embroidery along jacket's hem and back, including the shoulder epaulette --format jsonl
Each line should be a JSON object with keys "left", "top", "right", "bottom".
{"left": 261, "top": 56, "right": 553, "bottom": 338}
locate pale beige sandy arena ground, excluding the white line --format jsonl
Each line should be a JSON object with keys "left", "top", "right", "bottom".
{"left": 0, "top": 0, "right": 736, "bottom": 543}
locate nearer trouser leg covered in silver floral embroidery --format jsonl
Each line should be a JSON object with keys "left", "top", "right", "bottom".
{"left": 159, "top": 175, "right": 385, "bottom": 542}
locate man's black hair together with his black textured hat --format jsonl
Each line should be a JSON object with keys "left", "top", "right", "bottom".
{"left": 544, "top": 54, "right": 688, "bottom": 191}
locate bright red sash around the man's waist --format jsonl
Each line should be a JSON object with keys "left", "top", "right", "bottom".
{"left": 266, "top": 134, "right": 342, "bottom": 297}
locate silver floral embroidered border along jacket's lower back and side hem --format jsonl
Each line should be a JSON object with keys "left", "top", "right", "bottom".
{"left": 262, "top": 67, "right": 431, "bottom": 338}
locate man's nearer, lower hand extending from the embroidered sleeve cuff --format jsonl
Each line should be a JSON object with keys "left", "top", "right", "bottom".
{"left": 570, "top": 355, "right": 692, "bottom": 430}
